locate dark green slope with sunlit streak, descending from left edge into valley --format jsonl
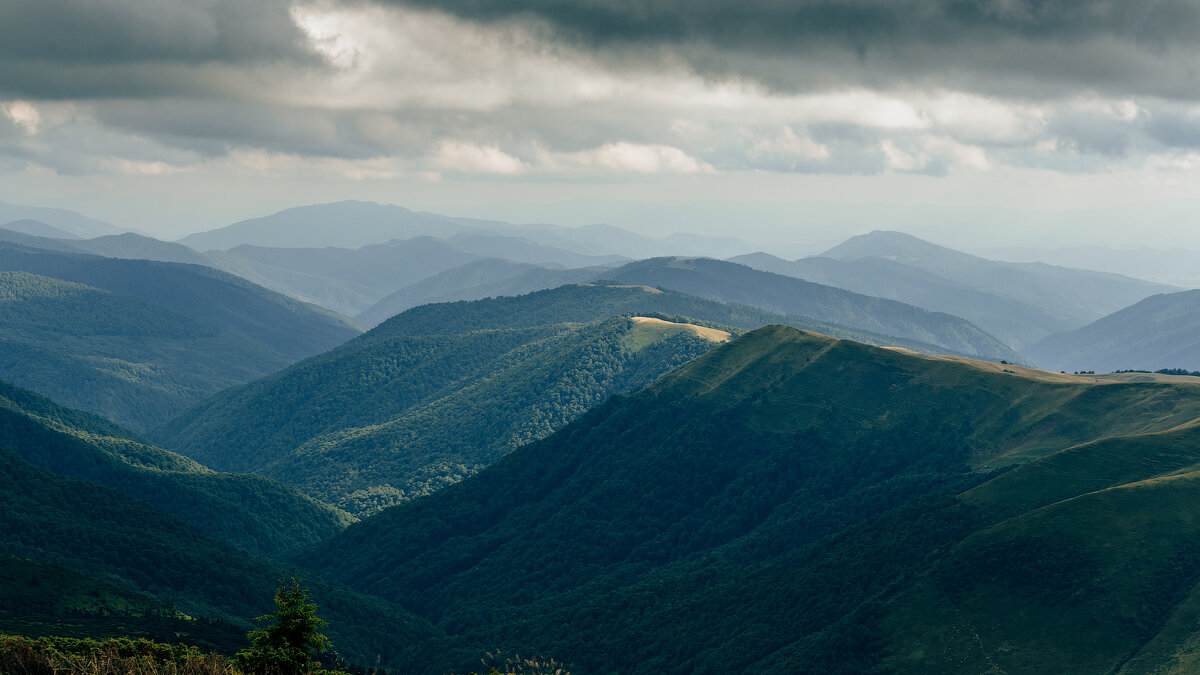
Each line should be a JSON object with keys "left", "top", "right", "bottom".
{"left": 0, "top": 374, "right": 350, "bottom": 555}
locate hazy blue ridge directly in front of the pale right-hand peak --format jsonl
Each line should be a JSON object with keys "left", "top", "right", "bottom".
{"left": 730, "top": 253, "right": 1076, "bottom": 350}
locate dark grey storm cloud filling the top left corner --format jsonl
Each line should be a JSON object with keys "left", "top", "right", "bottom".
{"left": 0, "top": 0, "right": 319, "bottom": 97}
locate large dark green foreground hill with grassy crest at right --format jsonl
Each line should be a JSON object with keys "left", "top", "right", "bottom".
{"left": 296, "top": 327, "right": 1200, "bottom": 673}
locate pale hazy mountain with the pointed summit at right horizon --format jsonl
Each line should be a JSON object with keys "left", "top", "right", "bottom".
{"left": 822, "top": 231, "right": 1177, "bottom": 327}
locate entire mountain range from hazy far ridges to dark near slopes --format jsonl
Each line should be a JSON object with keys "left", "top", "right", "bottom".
{"left": 11, "top": 195, "right": 1200, "bottom": 675}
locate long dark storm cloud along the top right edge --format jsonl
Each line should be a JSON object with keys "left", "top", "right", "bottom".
{"left": 385, "top": 0, "right": 1200, "bottom": 98}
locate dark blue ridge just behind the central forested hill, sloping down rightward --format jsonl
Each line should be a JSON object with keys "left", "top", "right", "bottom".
{"left": 605, "top": 258, "right": 1021, "bottom": 360}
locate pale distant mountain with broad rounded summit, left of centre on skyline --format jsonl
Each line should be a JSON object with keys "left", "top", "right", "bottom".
{"left": 180, "top": 201, "right": 468, "bottom": 251}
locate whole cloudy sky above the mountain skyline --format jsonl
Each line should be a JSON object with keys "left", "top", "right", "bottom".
{"left": 0, "top": 0, "right": 1200, "bottom": 252}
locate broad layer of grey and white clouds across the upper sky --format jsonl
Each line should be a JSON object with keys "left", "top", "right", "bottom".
{"left": 7, "top": 0, "right": 1200, "bottom": 186}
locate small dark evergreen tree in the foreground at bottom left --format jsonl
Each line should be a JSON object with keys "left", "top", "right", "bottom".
{"left": 238, "top": 577, "right": 334, "bottom": 675}
